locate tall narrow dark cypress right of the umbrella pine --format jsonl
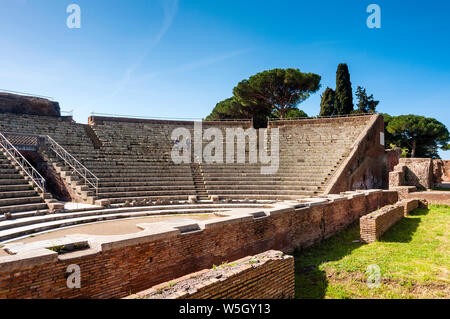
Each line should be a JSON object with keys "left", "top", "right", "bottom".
{"left": 335, "top": 63, "right": 353, "bottom": 115}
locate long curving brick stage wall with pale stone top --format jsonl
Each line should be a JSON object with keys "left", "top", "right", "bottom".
{"left": 0, "top": 190, "right": 398, "bottom": 298}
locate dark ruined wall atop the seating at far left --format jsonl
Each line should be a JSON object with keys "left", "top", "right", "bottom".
{"left": 0, "top": 92, "right": 61, "bottom": 116}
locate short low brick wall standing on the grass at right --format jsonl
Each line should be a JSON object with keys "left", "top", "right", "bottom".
{"left": 359, "top": 200, "right": 419, "bottom": 243}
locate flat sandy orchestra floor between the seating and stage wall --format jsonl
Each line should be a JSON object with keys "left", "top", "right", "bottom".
{"left": 6, "top": 214, "right": 220, "bottom": 245}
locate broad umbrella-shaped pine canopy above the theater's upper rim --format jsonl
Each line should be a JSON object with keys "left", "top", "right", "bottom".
{"left": 233, "top": 69, "right": 321, "bottom": 118}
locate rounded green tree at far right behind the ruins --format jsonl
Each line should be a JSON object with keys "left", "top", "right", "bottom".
{"left": 383, "top": 115, "right": 450, "bottom": 158}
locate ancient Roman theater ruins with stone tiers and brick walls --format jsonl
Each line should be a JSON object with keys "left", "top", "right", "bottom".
{"left": 0, "top": 95, "right": 448, "bottom": 298}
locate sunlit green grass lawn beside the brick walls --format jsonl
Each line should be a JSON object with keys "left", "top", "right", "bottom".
{"left": 295, "top": 206, "right": 450, "bottom": 299}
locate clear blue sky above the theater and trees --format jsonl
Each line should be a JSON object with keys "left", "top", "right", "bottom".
{"left": 0, "top": 0, "right": 450, "bottom": 158}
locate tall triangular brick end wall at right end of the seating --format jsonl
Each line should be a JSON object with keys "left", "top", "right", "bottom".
{"left": 325, "top": 115, "right": 391, "bottom": 194}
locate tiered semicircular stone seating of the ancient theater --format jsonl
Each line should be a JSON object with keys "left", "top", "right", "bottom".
{"left": 0, "top": 114, "right": 369, "bottom": 213}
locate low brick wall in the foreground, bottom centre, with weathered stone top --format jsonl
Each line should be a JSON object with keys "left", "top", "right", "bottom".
{"left": 126, "top": 250, "right": 295, "bottom": 299}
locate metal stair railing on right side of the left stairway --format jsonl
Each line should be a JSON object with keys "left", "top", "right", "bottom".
{"left": 45, "top": 135, "right": 99, "bottom": 194}
